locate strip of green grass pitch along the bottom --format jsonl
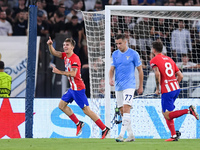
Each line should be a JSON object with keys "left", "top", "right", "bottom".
{"left": 0, "top": 138, "right": 200, "bottom": 150}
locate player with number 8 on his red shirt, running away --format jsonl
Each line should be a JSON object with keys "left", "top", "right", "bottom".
{"left": 150, "top": 42, "right": 199, "bottom": 141}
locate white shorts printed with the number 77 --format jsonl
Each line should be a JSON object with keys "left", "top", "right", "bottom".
{"left": 115, "top": 89, "right": 135, "bottom": 108}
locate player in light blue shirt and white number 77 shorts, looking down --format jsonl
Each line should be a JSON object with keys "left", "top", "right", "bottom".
{"left": 109, "top": 34, "right": 143, "bottom": 142}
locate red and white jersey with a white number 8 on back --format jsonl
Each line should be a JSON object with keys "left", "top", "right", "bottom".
{"left": 150, "top": 54, "right": 180, "bottom": 93}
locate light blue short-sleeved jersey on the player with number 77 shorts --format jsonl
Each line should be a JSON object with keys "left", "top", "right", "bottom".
{"left": 111, "top": 48, "right": 142, "bottom": 91}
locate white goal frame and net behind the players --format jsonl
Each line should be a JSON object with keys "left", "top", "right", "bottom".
{"left": 83, "top": 6, "right": 200, "bottom": 136}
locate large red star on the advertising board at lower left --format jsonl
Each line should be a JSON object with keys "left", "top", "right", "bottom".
{"left": 0, "top": 98, "right": 25, "bottom": 139}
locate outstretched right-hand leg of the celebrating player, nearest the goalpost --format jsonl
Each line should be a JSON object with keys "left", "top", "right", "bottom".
{"left": 74, "top": 90, "right": 110, "bottom": 139}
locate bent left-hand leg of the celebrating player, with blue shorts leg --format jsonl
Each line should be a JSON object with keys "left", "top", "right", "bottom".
{"left": 58, "top": 89, "right": 84, "bottom": 136}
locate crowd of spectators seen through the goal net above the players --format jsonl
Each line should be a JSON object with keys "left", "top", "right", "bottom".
{"left": 111, "top": 16, "right": 200, "bottom": 65}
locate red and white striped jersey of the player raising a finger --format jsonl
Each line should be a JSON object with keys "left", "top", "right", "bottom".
{"left": 61, "top": 52, "right": 85, "bottom": 91}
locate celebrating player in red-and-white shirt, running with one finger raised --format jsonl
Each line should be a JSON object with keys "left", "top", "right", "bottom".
{"left": 47, "top": 37, "right": 110, "bottom": 139}
